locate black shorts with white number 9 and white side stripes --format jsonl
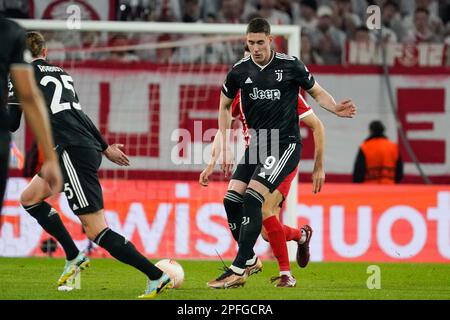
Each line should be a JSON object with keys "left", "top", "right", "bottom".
{"left": 231, "top": 143, "right": 302, "bottom": 192}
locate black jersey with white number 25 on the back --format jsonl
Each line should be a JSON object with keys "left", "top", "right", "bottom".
{"left": 8, "top": 59, "right": 108, "bottom": 152}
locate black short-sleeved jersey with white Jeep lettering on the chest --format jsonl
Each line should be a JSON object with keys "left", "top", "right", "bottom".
{"left": 222, "top": 51, "right": 315, "bottom": 144}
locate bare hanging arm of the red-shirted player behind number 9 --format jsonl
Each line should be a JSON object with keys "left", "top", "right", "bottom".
{"left": 301, "top": 113, "right": 325, "bottom": 193}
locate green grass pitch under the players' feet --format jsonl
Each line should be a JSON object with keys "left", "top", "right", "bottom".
{"left": 0, "top": 258, "right": 450, "bottom": 300}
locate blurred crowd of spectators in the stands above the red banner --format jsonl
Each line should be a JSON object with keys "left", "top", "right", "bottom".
{"left": 0, "top": 0, "right": 450, "bottom": 64}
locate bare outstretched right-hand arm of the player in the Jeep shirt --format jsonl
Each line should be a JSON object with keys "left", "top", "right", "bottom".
{"left": 307, "top": 82, "right": 356, "bottom": 118}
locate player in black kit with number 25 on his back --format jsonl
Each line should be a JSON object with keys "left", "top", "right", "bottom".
{"left": 9, "top": 32, "right": 172, "bottom": 298}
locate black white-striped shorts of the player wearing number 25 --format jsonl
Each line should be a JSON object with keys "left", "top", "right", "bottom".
{"left": 59, "top": 147, "right": 103, "bottom": 215}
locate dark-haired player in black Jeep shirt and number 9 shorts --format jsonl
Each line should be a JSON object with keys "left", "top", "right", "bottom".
{"left": 207, "top": 18, "right": 356, "bottom": 289}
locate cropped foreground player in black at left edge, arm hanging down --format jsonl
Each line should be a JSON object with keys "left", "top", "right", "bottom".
{"left": 0, "top": 16, "right": 62, "bottom": 218}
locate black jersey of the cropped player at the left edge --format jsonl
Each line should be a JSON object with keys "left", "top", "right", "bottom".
{"left": 0, "top": 17, "right": 26, "bottom": 132}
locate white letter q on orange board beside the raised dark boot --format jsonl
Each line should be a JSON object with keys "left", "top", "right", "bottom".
{"left": 292, "top": 204, "right": 324, "bottom": 261}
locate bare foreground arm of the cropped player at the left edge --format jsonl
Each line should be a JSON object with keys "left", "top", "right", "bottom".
{"left": 10, "top": 64, "right": 62, "bottom": 193}
